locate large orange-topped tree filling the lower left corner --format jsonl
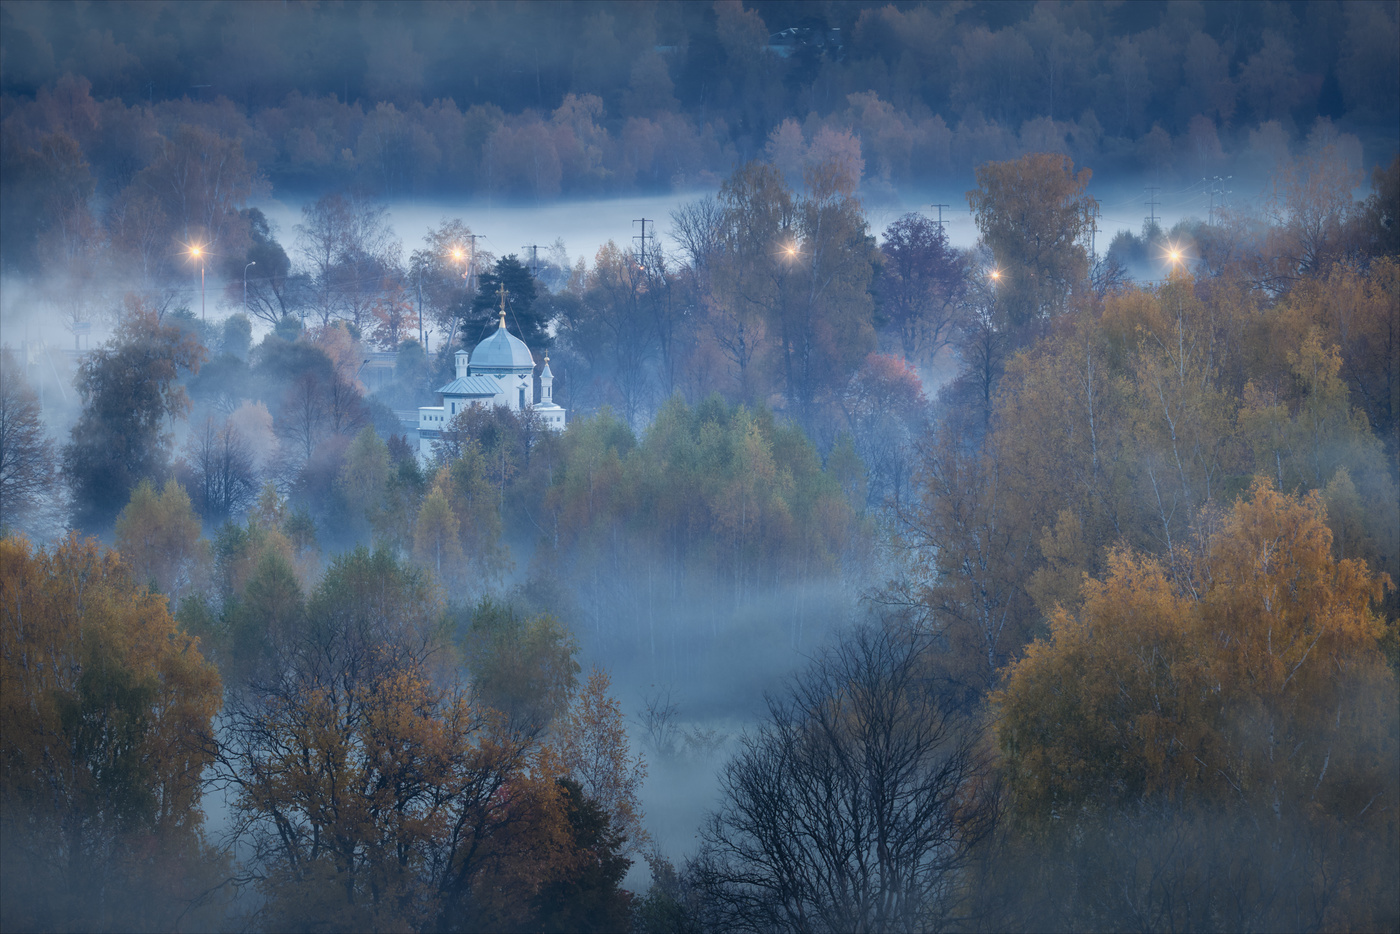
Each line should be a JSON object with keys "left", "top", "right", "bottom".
{"left": 0, "top": 536, "right": 225, "bottom": 930}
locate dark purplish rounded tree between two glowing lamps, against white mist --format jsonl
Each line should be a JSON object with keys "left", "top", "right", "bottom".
{"left": 875, "top": 214, "right": 966, "bottom": 365}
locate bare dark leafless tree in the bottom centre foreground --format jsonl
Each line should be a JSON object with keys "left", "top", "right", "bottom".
{"left": 696, "top": 627, "right": 994, "bottom": 931}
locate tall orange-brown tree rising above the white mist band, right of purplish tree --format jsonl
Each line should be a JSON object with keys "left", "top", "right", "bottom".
{"left": 967, "top": 153, "right": 1098, "bottom": 328}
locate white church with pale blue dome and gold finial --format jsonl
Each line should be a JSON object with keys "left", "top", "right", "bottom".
{"left": 419, "top": 293, "right": 567, "bottom": 458}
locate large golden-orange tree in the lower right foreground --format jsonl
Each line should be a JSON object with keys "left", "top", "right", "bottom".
{"left": 995, "top": 480, "right": 1400, "bottom": 927}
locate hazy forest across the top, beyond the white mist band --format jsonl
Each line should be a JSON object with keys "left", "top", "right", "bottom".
{"left": 3, "top": 1, "right": 1400, "bottom": 211}
